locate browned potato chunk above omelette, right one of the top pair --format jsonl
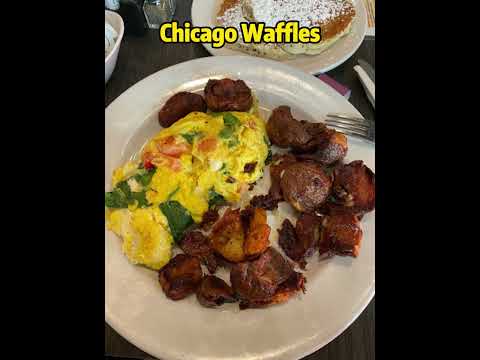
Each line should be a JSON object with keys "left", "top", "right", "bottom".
{"left": 204, "top": 79, "right": 253, "bottom": 112}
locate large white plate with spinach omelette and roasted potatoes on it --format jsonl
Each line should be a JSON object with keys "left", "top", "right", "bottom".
{"left": 105, "top": 56, "right": 375, "bottom": 360}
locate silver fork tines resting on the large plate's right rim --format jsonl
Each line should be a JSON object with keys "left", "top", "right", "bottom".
{"left": 324, "top": 114, "right": 375, "bottom": 142}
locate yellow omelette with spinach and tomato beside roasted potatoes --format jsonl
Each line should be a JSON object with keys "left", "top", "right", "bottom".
{"left": 105, "top": 112, "right": 271, "bottom": 270}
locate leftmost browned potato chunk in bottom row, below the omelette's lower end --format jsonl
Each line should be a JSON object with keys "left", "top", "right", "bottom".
{"left": 158, "top": 254, "right": 203, "bottom": 300}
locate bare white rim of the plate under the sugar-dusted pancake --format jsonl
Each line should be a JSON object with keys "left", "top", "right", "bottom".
{"left": 192, "top": 0, "right": 367, "bottom": 74}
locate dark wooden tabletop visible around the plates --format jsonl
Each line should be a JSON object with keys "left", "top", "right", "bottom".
{"left": 105, "top": 0, "right": 375, "bottom": 360}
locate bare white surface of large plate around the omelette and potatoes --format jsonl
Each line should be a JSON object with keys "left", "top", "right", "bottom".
{"left": 105, "top": 56, "right": 375, "bottom": 360}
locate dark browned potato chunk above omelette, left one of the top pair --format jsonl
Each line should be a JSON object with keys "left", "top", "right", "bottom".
{"left": 158, "top": 91, "right": 207, "bottom": 128}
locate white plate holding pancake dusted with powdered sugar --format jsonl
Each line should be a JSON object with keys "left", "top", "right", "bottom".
{"left": 192, "top": 0, "right": 367, "bottom": 74}
